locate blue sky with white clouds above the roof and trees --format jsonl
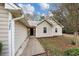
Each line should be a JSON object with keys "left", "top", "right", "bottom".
{"left": 18, "top": 3, "right": 57, "bottom": 15}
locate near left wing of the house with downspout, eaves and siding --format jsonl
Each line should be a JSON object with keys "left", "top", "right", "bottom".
{"left": 0, "top": 3, "right": 29, "bottom": 56}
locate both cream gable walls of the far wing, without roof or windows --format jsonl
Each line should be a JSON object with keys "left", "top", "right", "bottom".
{"left": 36, "top": 20, "right": 62, "bottom": 37}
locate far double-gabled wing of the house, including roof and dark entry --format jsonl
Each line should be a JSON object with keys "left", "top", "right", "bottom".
{"left": 28, "top": 17, "right": 63, "bottom": 37}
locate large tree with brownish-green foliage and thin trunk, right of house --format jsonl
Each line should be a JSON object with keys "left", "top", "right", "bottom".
{"left": 52, "top": 3, "right": 79, "bottom": 43}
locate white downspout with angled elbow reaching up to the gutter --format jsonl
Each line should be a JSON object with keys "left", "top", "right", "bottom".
{"left": 11, "top": 14, "right": 24, "bottom": 56}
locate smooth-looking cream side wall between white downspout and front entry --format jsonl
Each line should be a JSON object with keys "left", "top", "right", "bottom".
{"left": 15, "top": 21, "right": 28, "bottom": 53}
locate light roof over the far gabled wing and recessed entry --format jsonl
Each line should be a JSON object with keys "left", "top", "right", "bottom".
{"left": 27, "top": 17, "right": 64, "bottom": 28}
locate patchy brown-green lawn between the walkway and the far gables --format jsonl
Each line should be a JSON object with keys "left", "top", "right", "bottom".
{"left": 38, "top": 35, "right": 79, "bottom": 56}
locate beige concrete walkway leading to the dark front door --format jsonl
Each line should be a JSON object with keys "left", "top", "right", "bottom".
{"left": 21, "top": 37, "right": 45, "bottom": 56}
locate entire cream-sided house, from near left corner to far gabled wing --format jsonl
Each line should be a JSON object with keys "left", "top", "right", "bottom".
{"left": 0, "top": 3, "right": 63, "bottom": 56}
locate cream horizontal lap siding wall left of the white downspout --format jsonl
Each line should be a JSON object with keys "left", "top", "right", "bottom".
{"left": 0, "top": 9, "right": 9, "bottom": 56}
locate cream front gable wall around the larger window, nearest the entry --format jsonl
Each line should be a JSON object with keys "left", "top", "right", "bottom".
{"left": 36, "top": 21, "right": 53, "bottom": 37}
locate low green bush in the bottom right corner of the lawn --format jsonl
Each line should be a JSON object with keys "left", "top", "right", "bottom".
{"left": 64, "top": 48, "right": 79, "bottom": 56}
